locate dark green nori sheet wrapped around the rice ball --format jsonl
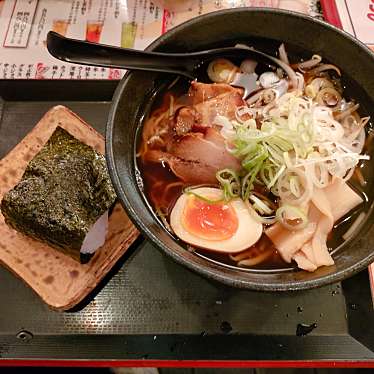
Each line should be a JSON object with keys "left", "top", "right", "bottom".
{"left": 1, "top": 127, "right": 116, "bottom": 260}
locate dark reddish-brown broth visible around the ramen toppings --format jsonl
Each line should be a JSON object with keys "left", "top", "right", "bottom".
{"left": 137, "top": 46, "right": 370, "bottom": 270}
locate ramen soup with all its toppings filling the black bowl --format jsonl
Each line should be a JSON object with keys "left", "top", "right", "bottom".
{"left": 137, "top": 45, "right": 371, "bottom": 271}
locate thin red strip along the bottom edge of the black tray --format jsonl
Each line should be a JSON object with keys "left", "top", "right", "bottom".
{"left": 0, "top": 359, "right": 374, "bottom": 368}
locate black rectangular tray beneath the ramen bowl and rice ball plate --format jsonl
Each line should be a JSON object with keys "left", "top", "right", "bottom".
{"left": 0, "top": 81, "right": 374, "bottom": 364}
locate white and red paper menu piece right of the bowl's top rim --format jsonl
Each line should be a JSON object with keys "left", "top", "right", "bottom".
{"left": 321, "top": 0, "right": 374, "bottom": 50}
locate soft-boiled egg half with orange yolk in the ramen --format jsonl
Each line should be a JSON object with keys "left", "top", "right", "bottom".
{"left": 170, "top": 187, "right": 262, "bottom": 253}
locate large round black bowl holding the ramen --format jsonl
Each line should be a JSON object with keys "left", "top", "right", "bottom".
{"left": 106, "top": 8, "right": 374, "bottom": 291}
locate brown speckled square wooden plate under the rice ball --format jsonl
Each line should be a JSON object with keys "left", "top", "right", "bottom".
{"left": 0, "top": 106, "right": 139, "bottom": 310}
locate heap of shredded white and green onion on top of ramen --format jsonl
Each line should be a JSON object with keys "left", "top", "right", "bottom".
{"left": 217, "top": 80, "right": 369, "bottom": 209}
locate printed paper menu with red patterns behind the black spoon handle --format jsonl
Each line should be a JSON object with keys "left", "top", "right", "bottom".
{"left": 0, "top": 0, "right": 315, "bottom": 79}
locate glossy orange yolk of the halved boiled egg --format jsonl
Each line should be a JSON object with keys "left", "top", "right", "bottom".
{"left": 182, "top": 196, "right": 239, "bottom": 240}
